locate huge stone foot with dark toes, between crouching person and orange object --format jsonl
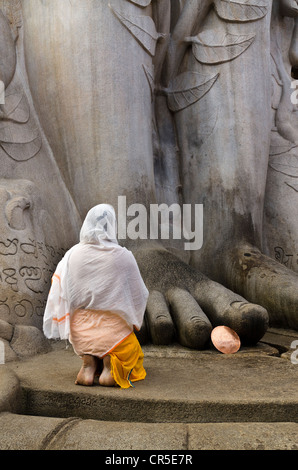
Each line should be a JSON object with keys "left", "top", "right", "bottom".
{"left": 134, "top": 247, "right": 268, "bottom": 349}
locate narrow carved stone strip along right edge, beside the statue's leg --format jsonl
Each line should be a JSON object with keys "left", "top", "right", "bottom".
{"left": 264, "top": 4, "right": 298, "bottom": 278}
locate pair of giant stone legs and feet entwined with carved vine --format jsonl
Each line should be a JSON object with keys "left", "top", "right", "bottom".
{"left": 1, "top": 0, "right": 298, "bottom": 348}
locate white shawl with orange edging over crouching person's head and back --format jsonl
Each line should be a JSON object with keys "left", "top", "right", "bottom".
{"left": 43, "top": 204, "right": 148, "bottom": 339}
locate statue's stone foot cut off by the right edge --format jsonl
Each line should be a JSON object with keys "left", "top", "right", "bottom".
{"left": 215, "top": 244, "right": 298, "bottom": 329}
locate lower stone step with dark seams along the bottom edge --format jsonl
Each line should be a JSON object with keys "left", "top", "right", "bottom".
{"left": 0, "top": 413, "right": 298, "bottom": 452}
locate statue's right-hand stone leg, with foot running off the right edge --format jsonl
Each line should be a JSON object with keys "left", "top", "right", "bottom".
{"left": 176, "top": 0, "right": 298, "bottom": 328}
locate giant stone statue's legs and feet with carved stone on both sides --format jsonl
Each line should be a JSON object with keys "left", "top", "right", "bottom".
{"left": 0, "top": 0, "right": 298, "bottom": 357}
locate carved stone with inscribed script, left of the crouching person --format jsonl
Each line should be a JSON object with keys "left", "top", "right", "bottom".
{"left": 0, "top": 1, "right": 80, "bottom": 361}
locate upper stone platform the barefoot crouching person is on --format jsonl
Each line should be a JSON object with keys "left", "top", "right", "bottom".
{"left": 6, "top": 344, "right": 298, "bottom": 424}
